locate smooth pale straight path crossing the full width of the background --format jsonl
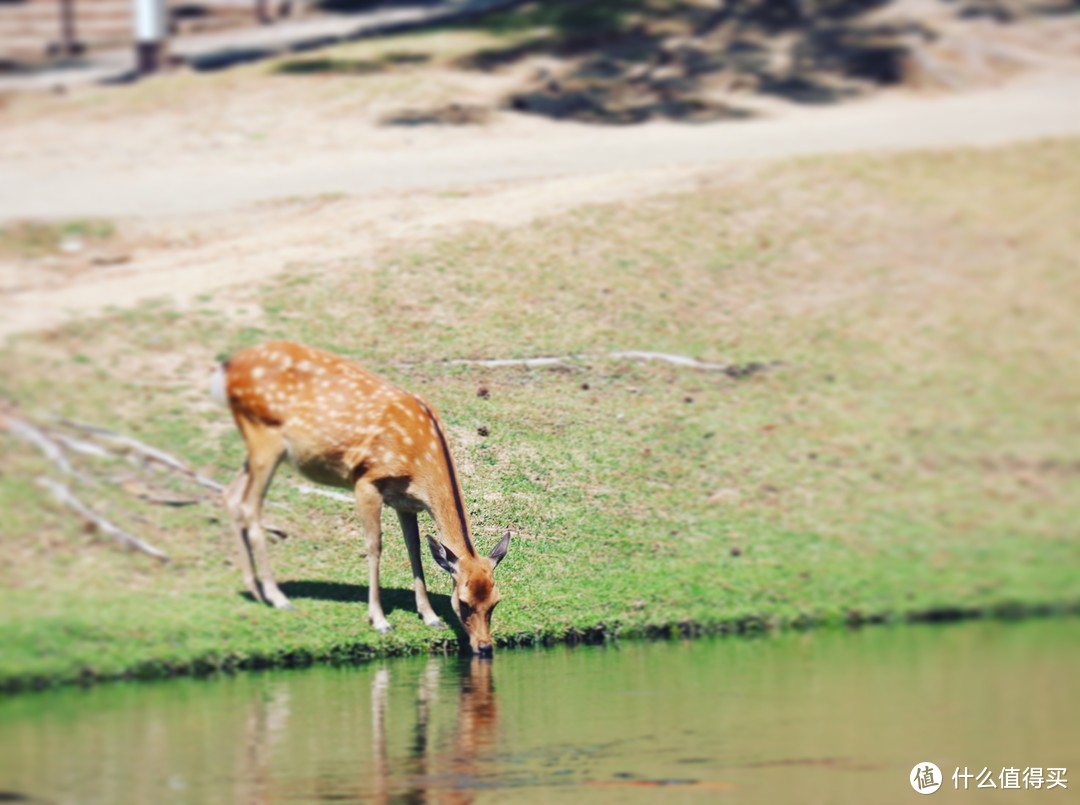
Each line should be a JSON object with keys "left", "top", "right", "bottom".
{"left": 0, "top": 76, "right": 1080, "bottom": 220}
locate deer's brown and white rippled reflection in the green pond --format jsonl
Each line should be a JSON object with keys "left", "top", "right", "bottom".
{"left": 233, "top": 657, "right": 499, "bottom": 803}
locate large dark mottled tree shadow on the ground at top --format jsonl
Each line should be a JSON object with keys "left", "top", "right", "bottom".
{"left": 447, "top": 0, "right": 929, "bottom": 124}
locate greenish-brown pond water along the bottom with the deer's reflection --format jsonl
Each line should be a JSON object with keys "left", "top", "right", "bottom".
{"left": 0, "top": 619, "right": 1080, "bottom": 804}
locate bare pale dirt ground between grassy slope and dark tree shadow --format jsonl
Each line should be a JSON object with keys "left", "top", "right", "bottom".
{"left": 0, "top": 3, "right": 1080, "bottom": 338}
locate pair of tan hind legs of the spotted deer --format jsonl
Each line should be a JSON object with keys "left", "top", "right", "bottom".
{"left": 226, "top": 419, "right": 294, "bottom": 609}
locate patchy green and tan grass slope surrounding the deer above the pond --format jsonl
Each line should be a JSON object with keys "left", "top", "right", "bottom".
{"left": 0, "top": 140, "right": 1080, "bottom": 687}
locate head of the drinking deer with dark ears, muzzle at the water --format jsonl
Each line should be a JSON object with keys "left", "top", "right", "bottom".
{"left": 428, "top": 531, "right": 510, "bottom": 657}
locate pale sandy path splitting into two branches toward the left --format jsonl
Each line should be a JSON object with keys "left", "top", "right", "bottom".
{"left": 0, "top": 73, "right": 1080, "bottom": 337}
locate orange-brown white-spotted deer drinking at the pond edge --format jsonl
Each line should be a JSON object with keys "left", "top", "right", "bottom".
{"left": 212, "top": 341, "right": 510, "bottom": 655}
